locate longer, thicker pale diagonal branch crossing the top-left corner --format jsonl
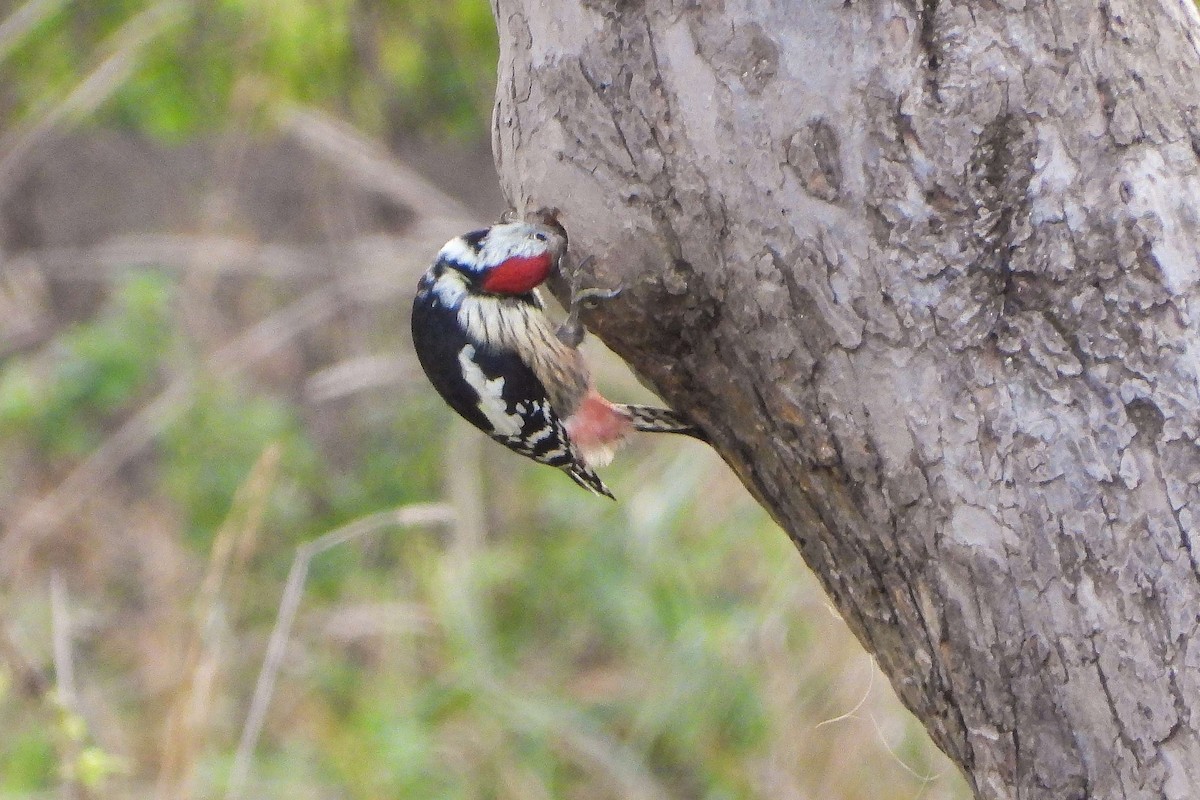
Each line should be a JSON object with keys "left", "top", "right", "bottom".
{"left": 0, "top": 0, "right": 186, "bottom": 191}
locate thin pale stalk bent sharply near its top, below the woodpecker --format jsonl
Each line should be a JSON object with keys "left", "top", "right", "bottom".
{"left": 226, "top": 504, "right": 455, "bottom": 800}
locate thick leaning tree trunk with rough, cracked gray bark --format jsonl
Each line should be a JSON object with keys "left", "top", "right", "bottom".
{"left": 493, "top": 0, "right": 1200, "bottom": 800}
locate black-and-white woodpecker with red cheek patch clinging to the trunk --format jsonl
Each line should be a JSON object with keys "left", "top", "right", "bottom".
{"left": 413, "top": 222, "right": 707, "bottom": 498}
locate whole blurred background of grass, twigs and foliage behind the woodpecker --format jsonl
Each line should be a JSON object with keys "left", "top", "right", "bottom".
{"left": 0, "top": 0, "right": 967, "bottom": 800}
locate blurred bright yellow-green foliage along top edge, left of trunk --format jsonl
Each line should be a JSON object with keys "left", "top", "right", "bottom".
{"left": 0, "top": 0, "right": 497, "bottom": 140}
